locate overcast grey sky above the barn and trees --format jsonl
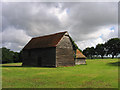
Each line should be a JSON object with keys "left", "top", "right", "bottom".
{"left": 0, "top": 2, "right": 118, "bottom": 51}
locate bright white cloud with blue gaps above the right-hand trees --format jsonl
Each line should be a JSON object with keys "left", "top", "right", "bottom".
{"left": 76, "top": 26, "right": 118, "bottom": 50}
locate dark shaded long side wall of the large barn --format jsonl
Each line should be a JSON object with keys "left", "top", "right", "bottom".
{"left": 22, "top": 48, "right": 56, "bottom": 67}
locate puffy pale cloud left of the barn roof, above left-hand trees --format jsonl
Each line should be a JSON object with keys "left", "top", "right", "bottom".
{"left": 2, "top": 27, "right": 31, "bottom": 51}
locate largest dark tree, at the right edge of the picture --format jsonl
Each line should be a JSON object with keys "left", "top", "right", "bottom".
{"left": 105, "top": 38, "right": 120, "bottom": 58}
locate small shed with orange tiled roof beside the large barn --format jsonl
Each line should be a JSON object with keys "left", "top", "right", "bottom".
{"left": 75, "top": 49, "right": 86, "bottom": 65}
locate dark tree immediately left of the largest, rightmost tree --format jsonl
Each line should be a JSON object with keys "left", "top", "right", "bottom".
{"left": 95, "top": 44, "right": 106, "bottom": 59}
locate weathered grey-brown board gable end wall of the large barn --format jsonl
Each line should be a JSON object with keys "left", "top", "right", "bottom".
{"left": 56, "top": 36, "right": 75, "bottom": 66}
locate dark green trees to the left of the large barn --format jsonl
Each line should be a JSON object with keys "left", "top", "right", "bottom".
{"left": 0, "top": 47, "right": 20, "bottom": 63}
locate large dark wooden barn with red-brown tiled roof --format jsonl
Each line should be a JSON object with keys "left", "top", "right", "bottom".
{"left": 22, "top": 32, "right": 75, "bottom": 67}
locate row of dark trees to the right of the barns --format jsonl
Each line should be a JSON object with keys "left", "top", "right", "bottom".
{"left": 83, "top": 38, "right": 120, "bottom": 59}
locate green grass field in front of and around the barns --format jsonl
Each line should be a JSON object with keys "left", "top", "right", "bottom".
{"left": 2, "top": 59, "right": 118, "bottom": 88}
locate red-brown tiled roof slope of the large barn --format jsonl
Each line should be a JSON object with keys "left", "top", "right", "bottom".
{"left": 23, "top": 31, "right": 67, "bottom": 49}
